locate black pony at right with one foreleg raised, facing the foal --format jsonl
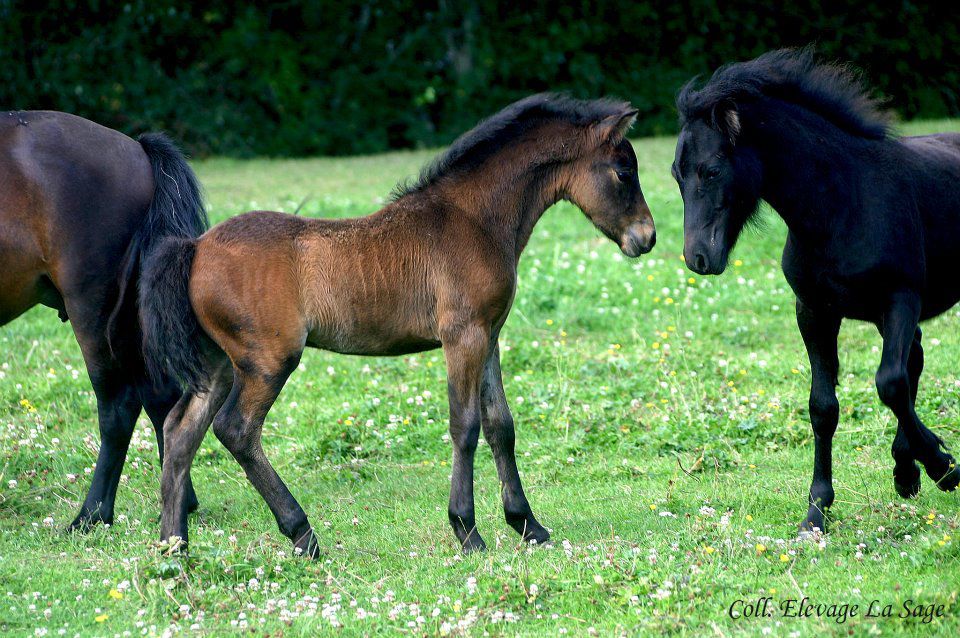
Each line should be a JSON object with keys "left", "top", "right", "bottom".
{"left": 673, "top": 49, "right": 960, "bottom": 532}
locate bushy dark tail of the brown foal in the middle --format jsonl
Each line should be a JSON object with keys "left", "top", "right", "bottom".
{"left": 140, "top": 237, "right": 208, "bottom": 393}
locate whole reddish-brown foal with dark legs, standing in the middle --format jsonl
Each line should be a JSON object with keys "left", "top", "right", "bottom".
{"left": 141, "top": 95, "right": 655, "bottom": 556}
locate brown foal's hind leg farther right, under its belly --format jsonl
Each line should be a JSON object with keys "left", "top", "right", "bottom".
{"left": 213, "top": 360, "right": 320, "bottom": 558}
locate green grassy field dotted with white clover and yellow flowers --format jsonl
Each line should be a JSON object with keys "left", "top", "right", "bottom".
{"left": 0, "top": 121, "right": 960, "bottom": 636}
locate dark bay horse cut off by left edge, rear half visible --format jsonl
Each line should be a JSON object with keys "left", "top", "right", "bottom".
{"left": 0, "top": 111, "right": 206, "bottom": 529}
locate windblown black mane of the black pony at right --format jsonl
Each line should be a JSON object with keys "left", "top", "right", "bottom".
{"left": 677, "top": 47, "right": 891, "bottom": 139}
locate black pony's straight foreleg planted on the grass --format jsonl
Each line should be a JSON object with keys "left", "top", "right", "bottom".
{"left": 797, "top": 299, "right": 842, "bottom": 534}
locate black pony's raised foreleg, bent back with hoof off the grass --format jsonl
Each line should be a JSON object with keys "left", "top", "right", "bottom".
{"left": 877, "top": 293, "right": 960, "bottom": 491}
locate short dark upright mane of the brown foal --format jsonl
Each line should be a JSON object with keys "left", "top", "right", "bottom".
{"left": 392, "top": 93, "right": 630, "bottom": 201}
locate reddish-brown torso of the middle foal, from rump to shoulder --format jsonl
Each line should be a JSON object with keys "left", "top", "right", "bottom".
{"left": 190, "top": 201, "right": 514, "bottom": 368}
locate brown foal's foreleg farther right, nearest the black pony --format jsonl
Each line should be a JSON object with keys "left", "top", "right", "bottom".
{"left": 480, "top": 344, "right": 550, "bottom": 543}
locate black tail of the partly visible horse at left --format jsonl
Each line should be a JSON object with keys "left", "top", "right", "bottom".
{"left": 107, "top": 133, "right": 208, "bottom": 381}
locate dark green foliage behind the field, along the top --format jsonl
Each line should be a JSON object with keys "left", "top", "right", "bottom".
{"left": 0, "top": 0, "right": 960, "bottom": 156}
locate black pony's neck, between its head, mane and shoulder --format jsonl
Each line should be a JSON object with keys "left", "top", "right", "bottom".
{"left": 738, "top": 99, "right": 878, "bottom": 241}
